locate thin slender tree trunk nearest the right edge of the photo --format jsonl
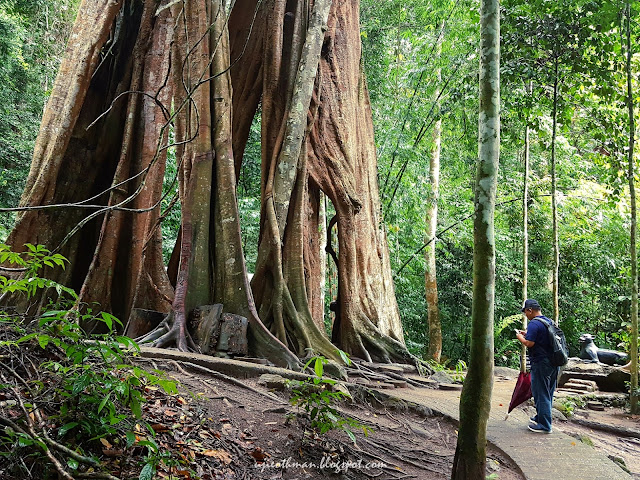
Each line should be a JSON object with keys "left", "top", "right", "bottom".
{"left": 625, "top": 1, "right": 638, "bottom": 414}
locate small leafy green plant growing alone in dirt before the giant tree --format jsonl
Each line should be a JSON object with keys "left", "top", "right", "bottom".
{"left": 289, "top": 352, "right": 371, "bottom": 443}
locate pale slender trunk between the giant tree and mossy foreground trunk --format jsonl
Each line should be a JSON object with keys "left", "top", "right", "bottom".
{"left": 424, "top": 21, "right": 444, "bottom": 363}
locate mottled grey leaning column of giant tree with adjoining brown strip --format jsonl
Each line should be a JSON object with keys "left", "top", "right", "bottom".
{"left": 238, "top": 0, "right": 339, "bottom": 359}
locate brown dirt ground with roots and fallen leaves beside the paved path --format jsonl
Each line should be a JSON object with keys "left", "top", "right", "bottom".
{"left": 147, "top": 362, "right": 523, "bottom": 480}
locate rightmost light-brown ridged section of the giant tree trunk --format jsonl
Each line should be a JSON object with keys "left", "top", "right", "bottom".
{"left": 309, "top": 2, "right": 408, "bottom": 361}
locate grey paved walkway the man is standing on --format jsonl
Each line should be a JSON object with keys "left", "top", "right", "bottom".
{"left": 385, "top": 379, "right": 632, "bottom": 480}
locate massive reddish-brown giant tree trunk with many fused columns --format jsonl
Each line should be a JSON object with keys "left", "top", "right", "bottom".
{"left": 3, "top": 0, "right": 415, "bottom": 367}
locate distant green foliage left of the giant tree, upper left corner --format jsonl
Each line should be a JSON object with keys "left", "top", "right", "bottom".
{"left": 0, "top": 0, "right": 78, "bottom": 234}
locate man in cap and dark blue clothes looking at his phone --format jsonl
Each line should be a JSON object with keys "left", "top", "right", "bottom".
{"left": 516, "top": 298, "right": 558, "bottom": 433}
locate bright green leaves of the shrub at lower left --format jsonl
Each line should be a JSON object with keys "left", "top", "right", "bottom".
{"left": 0, "top": 245, "right": 177, "bottom": 478}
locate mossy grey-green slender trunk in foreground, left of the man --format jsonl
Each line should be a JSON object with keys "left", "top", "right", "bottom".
{"left": 451, "top": 0, "right": 500, "bottom": 474}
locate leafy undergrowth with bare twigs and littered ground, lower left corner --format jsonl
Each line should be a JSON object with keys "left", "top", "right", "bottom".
{"left": 0, "top": 244, "right": 184, "bottom": 480}
